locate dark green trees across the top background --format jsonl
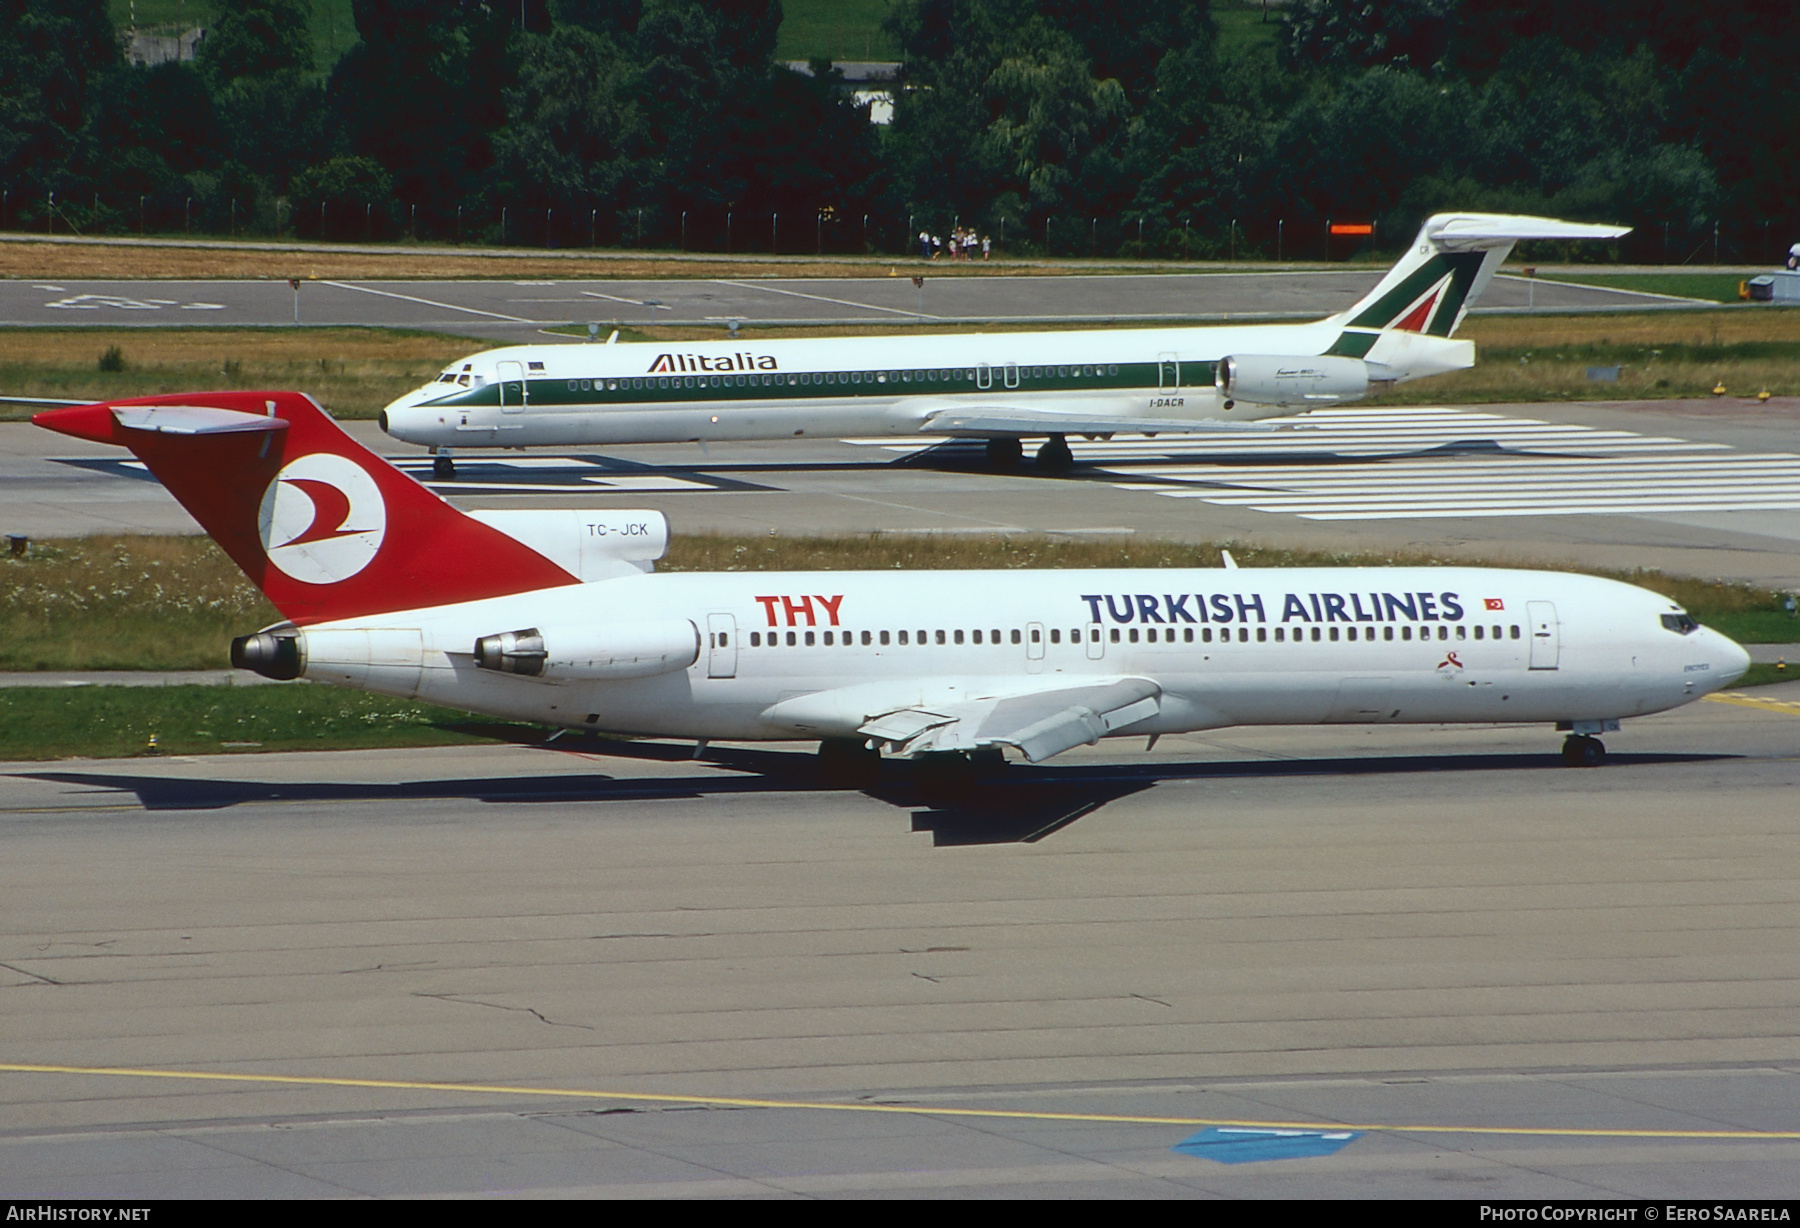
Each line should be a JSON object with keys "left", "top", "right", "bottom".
{"left": 0, "top": 0, "right": 1800, "bottom": 259}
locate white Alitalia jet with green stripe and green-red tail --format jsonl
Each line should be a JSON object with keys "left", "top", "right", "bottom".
{"left": 382, "top": 212, "right": 1627, "bottom": 477}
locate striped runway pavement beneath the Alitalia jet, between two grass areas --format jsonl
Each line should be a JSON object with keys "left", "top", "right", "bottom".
{"left": 0, "top": 398, "right": 1800, "bottom": 589}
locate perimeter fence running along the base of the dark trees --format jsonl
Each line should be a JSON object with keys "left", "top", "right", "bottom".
{"left": 0, "top": 187, "right": 1800, "bottom": 266}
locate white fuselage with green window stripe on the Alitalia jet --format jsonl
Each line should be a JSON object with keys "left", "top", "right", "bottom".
{"left": 382, "top": 321, "right": 1472, "bottom": 448}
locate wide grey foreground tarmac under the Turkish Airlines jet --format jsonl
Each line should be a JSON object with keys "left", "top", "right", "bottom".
{"left": 0, "top": 686, "right": 1800, "bottom": 1197}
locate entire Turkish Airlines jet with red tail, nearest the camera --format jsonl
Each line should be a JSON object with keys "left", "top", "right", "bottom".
{"left": 34, "top": 393, "right": 1748, "bottom": 781}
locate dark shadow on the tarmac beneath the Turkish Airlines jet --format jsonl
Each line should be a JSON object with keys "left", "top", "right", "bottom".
{"left": 14, "top": 738, "right": 1737, "bottom": 848}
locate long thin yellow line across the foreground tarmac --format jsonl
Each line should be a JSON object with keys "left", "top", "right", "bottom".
{"left": 0, "top": 1062, "right": 1800, "bottom": 1142}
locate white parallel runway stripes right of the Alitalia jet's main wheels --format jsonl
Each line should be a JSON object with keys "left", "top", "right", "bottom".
{"left": 855, "top": 407, "right": 1800, "bottom": 520}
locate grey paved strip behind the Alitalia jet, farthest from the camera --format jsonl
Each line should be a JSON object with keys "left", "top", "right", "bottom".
{"left": 0, "top": 265, "right": 1684, "bottom": 342}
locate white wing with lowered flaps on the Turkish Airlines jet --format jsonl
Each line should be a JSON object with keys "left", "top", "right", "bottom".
{"left": 763, "top": 675, "right": 1163, "bottom": 763}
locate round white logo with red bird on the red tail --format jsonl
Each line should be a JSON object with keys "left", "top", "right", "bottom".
{"left": 257, "top": 452, "right": 387, "bottom": 583}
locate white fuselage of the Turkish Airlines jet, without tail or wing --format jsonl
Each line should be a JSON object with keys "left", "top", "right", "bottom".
{"left": 291, "top": 567, "right": 1748, "bottom": 751}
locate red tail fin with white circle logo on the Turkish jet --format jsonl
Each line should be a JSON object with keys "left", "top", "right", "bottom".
{"left": 32, "top": 393, "right": 576, "bottom": 627}
